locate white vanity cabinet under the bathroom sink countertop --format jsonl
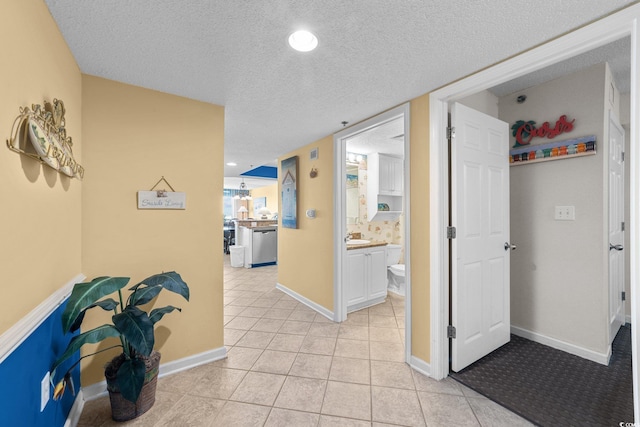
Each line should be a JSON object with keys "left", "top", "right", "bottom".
{"left": 346, "top": 246, "right": 387, "bottom": 312}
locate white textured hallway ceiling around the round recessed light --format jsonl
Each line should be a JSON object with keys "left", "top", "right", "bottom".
{"left": 45, "top": 0, "right": 632, "bottom": 183}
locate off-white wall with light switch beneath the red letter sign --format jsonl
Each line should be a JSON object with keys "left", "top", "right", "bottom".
{"left": 498, "top": 64, "right": 609, "bottom": 354}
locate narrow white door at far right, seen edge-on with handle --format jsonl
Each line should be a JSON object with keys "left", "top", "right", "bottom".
{"left": 609, "top": 112, "right": 625, "bottom": 342}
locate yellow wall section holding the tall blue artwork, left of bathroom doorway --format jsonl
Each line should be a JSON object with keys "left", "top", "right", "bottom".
{"left": 278, "top": 136, "right": 334, "bottom": 311}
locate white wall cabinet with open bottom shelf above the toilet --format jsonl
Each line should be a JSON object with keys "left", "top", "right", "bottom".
{"left": 367, "top": 153, "right": 404, "bottom": 221}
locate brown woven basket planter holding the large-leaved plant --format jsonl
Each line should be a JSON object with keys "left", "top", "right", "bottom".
{"left": 104, "top": 351, "right": 160, "bottom": 421}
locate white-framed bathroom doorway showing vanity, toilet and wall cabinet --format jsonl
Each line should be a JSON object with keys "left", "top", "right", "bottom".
{"left": 334, "top": 104, "right": 411, "bottom": 360}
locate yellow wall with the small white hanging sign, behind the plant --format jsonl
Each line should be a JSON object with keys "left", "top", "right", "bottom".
{"left": 82, "top": 76, "right": 224, "bottom": 385}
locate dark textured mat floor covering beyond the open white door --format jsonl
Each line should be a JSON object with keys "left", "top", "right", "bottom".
{"left": 450, "top": 324, "right": 633, "bottom": 426}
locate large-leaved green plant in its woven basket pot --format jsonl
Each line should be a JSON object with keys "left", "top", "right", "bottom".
{"left": 51, "top": 271, "right": 189, "bottom": 421}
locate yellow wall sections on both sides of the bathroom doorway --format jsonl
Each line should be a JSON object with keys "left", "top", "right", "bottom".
{"left": 278, "top": 99, "right": 431, "bottom": 363}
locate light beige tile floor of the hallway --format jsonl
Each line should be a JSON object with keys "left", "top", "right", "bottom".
{"left": 78, "top": 256, "right": 530, "bottom": 427}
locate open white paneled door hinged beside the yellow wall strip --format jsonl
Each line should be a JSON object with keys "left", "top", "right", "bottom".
{"left": 451, "top": 103, "right": 515, "bottom": 372}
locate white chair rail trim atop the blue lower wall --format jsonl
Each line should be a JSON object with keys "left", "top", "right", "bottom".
{"left": 0, "top": 273, "right": 86, "bottom": 363}
